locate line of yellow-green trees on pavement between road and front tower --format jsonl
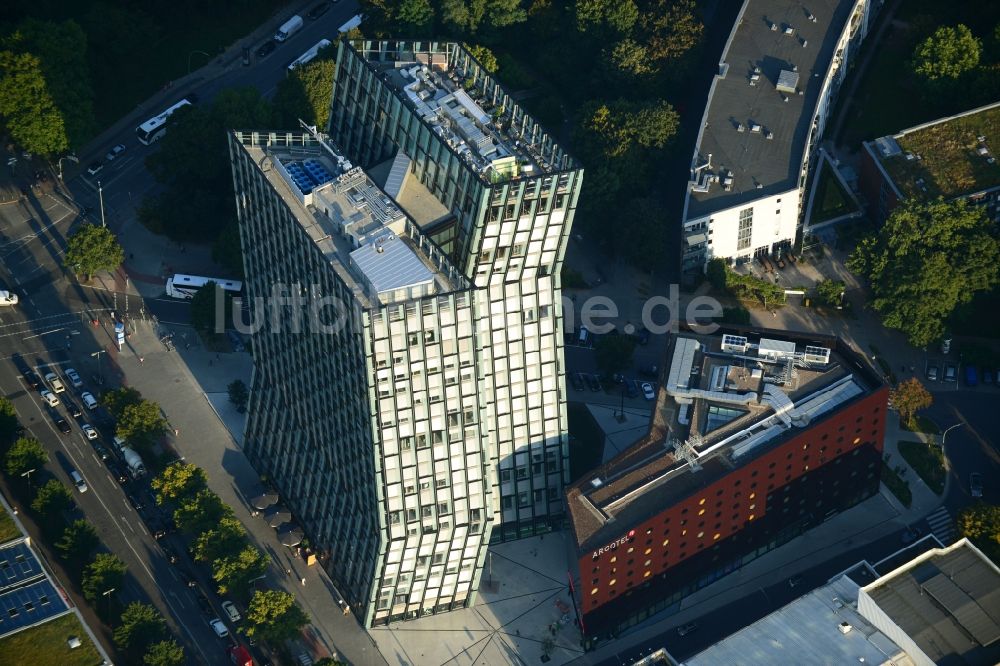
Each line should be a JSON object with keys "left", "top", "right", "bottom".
{"left": 152, "top": 462, "right": 310, "bottom": 643}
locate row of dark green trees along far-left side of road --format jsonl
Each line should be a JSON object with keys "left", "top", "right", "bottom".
{"left": 0, "top": 398, "right": 186, "bottom": 666}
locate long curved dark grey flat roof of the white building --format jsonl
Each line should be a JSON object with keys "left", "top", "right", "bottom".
{"left": 687, "top": 0, "right": 854, "bottom": 219}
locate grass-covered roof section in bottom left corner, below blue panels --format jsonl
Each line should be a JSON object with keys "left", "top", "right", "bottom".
{"left": 0, "top": 613, "right": 102, "bottom": 666}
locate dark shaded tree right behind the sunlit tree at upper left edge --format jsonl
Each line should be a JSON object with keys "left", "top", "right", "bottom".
{"left": 8, "top": 18, "right": 96, "bottom": 147}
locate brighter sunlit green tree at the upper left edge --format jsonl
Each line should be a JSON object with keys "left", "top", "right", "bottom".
{"left": 0, "top": 50, "right": 69, "bottom": 156}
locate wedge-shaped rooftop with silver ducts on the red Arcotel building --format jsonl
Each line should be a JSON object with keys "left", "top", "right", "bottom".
{"left": 567, "top": 331, "right": 881, "bottom": 551}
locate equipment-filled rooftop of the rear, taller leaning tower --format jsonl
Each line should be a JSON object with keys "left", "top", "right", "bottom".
{"left": 351, "top": 40, "right": 578, "bottom": 183}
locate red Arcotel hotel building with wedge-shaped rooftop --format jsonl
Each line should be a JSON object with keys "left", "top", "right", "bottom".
{"left": 567, "top": 330, "right": 888, "bottom": 644}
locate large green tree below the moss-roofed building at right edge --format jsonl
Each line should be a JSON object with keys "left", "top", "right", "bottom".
{"left": 847, "top": 198, "right": 1000, "bottom": 347}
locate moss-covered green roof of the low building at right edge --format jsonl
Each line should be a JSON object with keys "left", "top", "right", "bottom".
{"left": 868, "top": 102, "right": 1000, "bottom": 199}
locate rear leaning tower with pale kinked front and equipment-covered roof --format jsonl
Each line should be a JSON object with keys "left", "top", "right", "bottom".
{"left": 329, "top": 40, "right": 583, "bottom": 541}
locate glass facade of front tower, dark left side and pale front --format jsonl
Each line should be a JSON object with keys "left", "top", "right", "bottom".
{"left": 230, "top": 132, "right": 496, "bottom": 626}
